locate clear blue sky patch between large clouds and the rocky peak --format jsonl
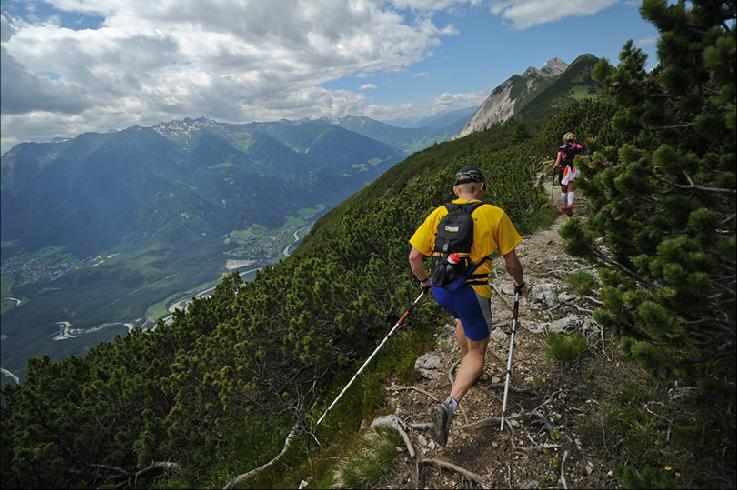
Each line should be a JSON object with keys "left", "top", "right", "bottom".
{"left": 326, "top": 2, "right": 657, "bottom": 104}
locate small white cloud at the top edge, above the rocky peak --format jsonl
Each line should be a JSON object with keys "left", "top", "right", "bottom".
{"left": 490, "top": 0, "right": 618, "bottom": 29}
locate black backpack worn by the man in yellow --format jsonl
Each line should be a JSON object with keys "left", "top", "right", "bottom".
{"left": 430, "top": 202, "right": 484, "bottom": 289}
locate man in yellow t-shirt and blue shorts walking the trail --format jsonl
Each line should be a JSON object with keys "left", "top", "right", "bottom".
{"left": 409, "top": 166, "right": 524, "bottom": 446}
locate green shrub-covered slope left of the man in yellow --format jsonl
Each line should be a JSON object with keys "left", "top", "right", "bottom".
{"left": 2, "top": 102, "right": 568, "bottom": 486}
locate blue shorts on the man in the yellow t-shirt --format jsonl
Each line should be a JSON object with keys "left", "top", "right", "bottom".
{"left": 432, "top": 284, "right": 492, "bottom": 340}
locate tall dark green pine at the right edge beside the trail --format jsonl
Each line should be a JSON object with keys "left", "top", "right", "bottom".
{"left": 562, "top": 0, "right": 736, "bottom": 382}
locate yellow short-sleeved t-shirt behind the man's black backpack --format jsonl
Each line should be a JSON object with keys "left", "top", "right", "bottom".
{"left": 409, "top": 199, "right": 522, "bottom": 298}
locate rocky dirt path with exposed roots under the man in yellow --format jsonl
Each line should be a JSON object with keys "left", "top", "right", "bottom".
{"left": 374, "top": 195, "right": 626, "bottom": 488}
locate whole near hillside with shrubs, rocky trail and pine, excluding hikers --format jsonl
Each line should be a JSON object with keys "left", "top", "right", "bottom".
{"left": 0, "top": 1, "right": 737, "bottom": 488}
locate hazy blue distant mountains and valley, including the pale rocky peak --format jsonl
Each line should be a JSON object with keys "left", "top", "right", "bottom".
{"left": 0, "top": 55, "right": 598, "bottom": 382}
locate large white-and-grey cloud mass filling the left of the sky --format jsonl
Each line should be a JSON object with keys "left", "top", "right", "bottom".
{"left": 1, "top": 0, "right": 460, "bottom": 150}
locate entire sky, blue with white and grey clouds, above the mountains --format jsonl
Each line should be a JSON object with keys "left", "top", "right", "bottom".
{"left": 0, "top": 0, "right": 656, "bottom": 151}
